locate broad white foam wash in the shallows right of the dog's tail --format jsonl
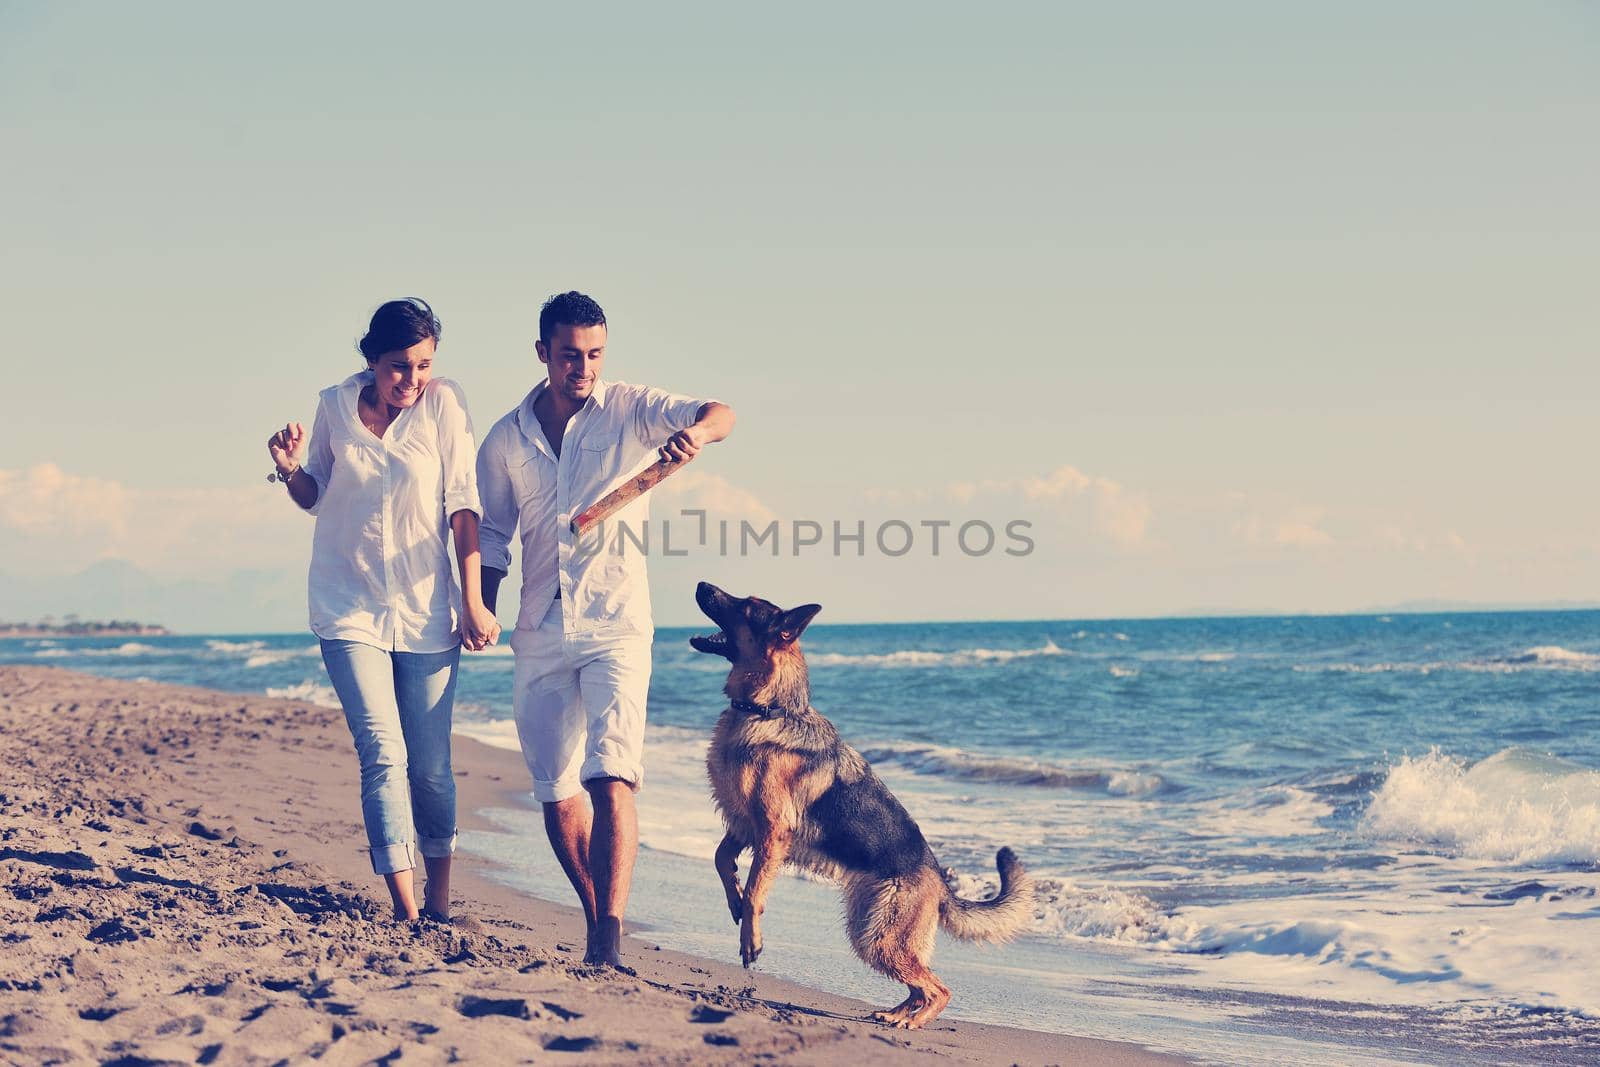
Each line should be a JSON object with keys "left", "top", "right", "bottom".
{"left": 949, "top": 859, "right": 1600, "bottom": 1016}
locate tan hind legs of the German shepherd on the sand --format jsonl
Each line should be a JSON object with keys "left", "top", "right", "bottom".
{"left": 845, "top": 872, "right": 950, "bottom": 1029}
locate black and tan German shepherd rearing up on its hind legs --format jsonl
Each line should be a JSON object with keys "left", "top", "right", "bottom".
{"left": 690, "top": 582, "right": 1034, "bottom": 1029}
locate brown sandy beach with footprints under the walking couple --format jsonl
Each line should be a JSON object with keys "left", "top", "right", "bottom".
{"left": 0, "top": 667, "right": 1176, "bottom": 1065}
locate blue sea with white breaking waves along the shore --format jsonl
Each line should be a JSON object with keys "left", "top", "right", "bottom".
{"left": 0, "top": 611, "right": 1600, "bottom": 1064}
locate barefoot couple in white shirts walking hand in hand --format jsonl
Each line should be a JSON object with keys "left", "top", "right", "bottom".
{"left": 267, "top": 293, "right": 734, "bottom": 966}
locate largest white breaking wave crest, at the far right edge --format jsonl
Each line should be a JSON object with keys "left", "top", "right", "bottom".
{"left": 1363, "top": 749, "right": 1600, "bottom": 865}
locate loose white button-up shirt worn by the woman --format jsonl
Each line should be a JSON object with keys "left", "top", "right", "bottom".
{"left": 306, "top": 371, "right": 483, "bottom": 653}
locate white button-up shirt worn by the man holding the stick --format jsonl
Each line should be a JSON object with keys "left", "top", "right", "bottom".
{"left": 478, "top": 381, "right": 712, "bottom": 639}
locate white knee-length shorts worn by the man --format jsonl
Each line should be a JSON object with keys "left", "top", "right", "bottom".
{"left": 512, "top": 600, "right": 650, "bottom": 803}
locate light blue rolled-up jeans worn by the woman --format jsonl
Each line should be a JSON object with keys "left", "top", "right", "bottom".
{"left": 322, "top": 641, "right": 461, "bottom": 875}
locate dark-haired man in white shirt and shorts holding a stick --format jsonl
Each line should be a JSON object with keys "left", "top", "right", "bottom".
{"left": 478, "top": 293, "right": 734, "bottom": 966}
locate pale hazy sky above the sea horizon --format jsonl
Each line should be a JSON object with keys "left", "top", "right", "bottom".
{"left": 0, "top": 3, "right": 1600, "bottom": 629}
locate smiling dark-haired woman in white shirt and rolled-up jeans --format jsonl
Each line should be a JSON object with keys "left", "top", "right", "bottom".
{"left": 267, "top": 299, "right": 499, "bottom": 921}
